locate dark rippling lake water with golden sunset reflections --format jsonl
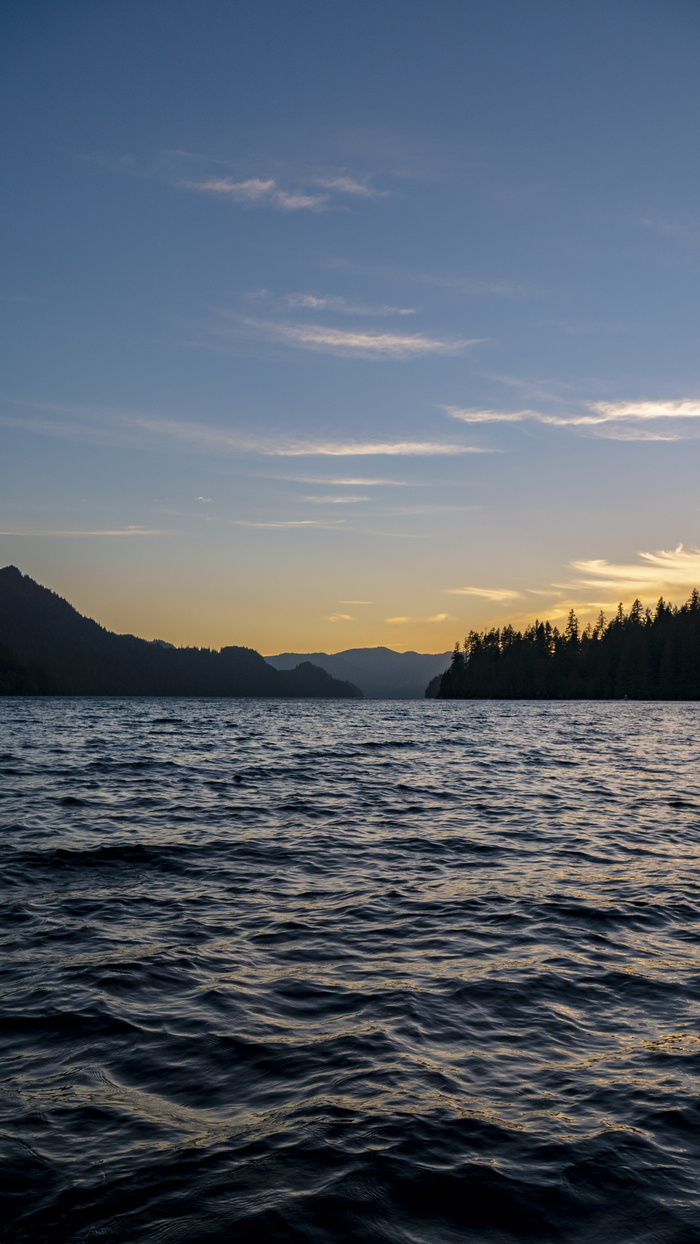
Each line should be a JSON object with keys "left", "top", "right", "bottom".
{"left": 0, "top": 699, "right": 700, "bottom": 1244}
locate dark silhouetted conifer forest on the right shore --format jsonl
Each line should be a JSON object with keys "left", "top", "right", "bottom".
{"left": 438, "top": 588, "right": 700, "bottom": 700}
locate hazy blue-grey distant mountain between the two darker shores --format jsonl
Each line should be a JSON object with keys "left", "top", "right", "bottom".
{"left": 265, "top": 648, "right": 453, "bottom": 699}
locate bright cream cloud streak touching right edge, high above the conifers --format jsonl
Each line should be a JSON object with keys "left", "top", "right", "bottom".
{"left": 443, "top": 398, "right": 700, "bottom": 440}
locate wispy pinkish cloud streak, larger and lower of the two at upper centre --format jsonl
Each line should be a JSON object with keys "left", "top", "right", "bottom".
{"left": 242, "top": 320, "right": 486, "bottom": 360}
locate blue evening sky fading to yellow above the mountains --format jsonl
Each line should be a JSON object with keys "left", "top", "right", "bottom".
{"left": 0, "top": 0, "right": 700, "bottom": 653}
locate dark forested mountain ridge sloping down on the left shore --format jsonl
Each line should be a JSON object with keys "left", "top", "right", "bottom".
{"left": 0, "top": 566, "right": 362, "bottom": 698}
